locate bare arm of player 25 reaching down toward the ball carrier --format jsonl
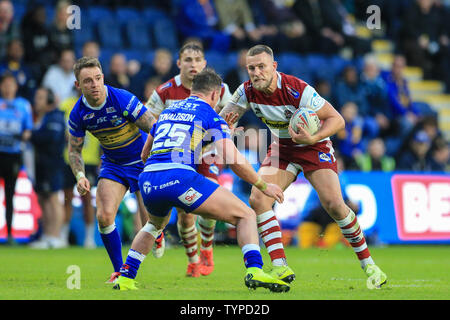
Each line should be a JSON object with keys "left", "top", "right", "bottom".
{"left": 216, "top": 139, "right": 284, "bottom": 203}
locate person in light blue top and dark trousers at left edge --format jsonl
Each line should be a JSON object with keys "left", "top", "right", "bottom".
{"left": 0, "top": 73, "right": 33, "bottom": 244}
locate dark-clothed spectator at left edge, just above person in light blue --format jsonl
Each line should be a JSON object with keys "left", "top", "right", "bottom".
{"left": 0, "top": 39, "right": 37, "bottom": 99}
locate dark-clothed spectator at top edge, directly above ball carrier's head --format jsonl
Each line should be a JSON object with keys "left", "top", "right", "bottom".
{"left": 255, "top": 0, "right": 310, "bottom": 53}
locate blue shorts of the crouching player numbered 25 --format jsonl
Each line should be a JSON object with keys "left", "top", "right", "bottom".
{"left": 139, "top": 169, "right": 219, "bottom": 217}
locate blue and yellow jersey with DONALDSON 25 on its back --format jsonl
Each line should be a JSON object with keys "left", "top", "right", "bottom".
{"left": 145, "top": 96, "right": 230, "bottom": 171}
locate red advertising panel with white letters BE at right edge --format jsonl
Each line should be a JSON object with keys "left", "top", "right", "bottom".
{"left": 391, "top": 174, "right": 450, "bottom": 241}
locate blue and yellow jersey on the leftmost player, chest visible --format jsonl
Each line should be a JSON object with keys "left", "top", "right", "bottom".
{"left": 68, "top": 85, "right": 147, "bottom": 165}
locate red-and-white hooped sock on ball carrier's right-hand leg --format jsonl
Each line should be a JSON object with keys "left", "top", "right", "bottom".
{"left": 336, "top": 210, "right": 375, "bottom": 269}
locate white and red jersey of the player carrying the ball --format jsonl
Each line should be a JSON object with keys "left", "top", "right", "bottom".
{"left": 230, "top": 72, "right": 329, "bottom": 146}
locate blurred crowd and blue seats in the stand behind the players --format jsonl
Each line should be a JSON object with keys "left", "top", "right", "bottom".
{"left": 0, "top": 0, "right": 450, "bottom": 246}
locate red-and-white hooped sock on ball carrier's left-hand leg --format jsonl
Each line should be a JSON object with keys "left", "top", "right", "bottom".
{"left": 256, "top": 210, "right": 286, "bottom": 266}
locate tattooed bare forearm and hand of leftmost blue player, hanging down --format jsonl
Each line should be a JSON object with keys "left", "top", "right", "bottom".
{"left": 68, "top": 133, "right": 91, "bottom": 196}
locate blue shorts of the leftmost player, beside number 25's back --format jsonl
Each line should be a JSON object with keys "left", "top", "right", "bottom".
{"left": 98, "top": 159, "right": 144, "bottom": 193}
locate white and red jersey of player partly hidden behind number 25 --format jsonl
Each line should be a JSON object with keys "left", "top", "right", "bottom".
{"left": 146, "top": 75, "right": 231, "bottom": 116}
